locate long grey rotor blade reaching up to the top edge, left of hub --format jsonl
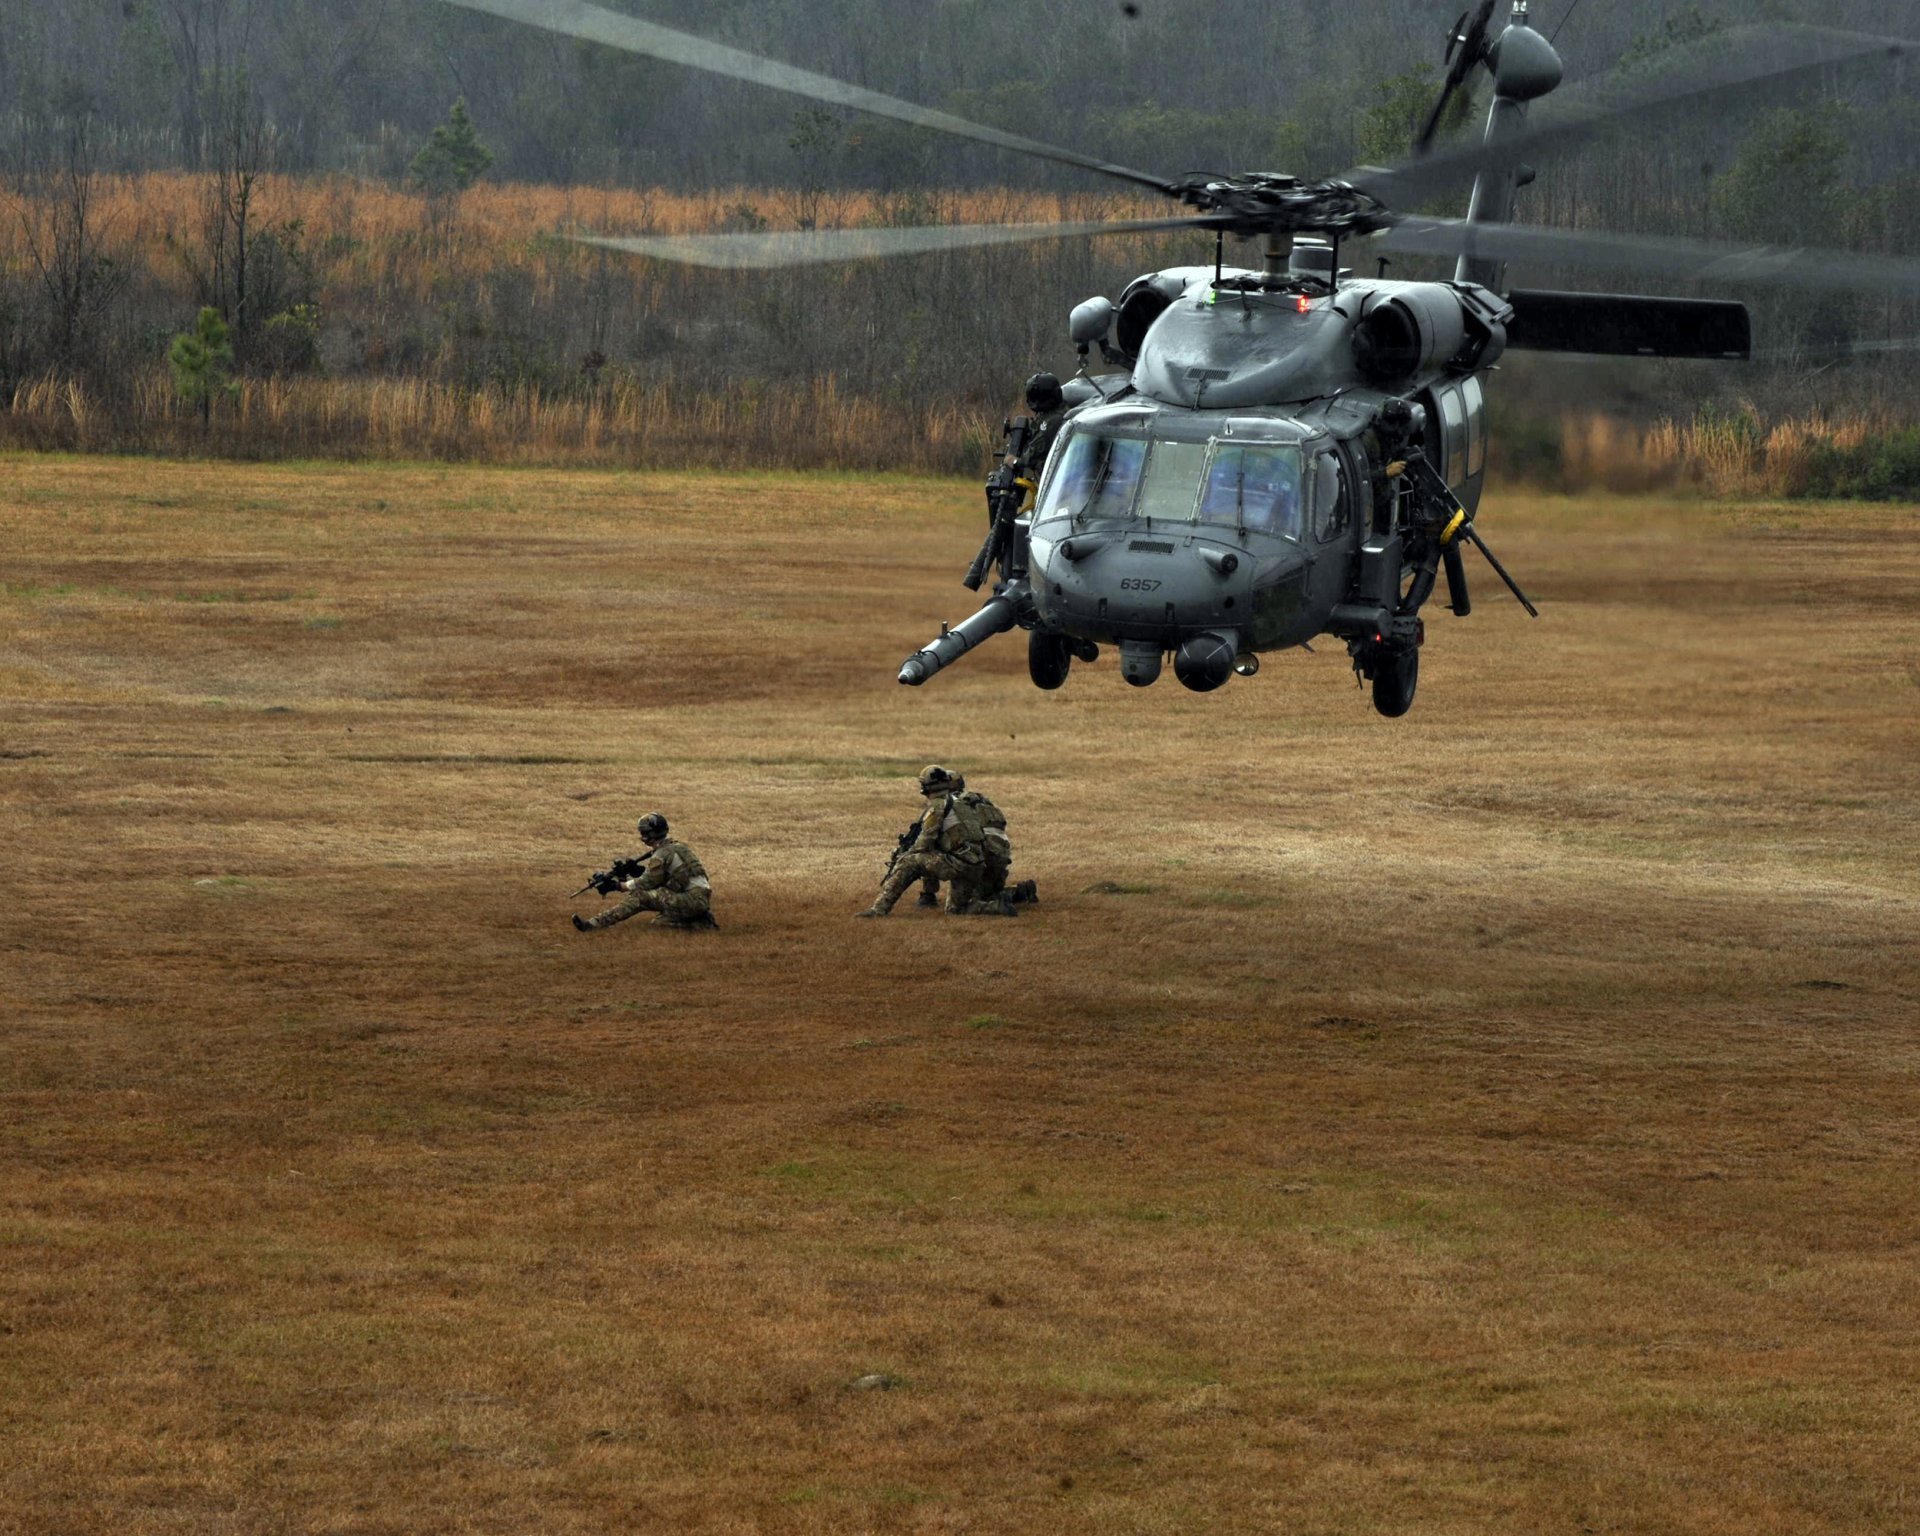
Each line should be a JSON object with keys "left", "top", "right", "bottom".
{"left": 445, "top": 0, "right": 1177, "bottom": 194}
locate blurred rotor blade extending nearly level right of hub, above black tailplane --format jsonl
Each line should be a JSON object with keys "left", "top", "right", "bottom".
{"left": 1375, "top": 219, "right": 1920, "bottom": 298}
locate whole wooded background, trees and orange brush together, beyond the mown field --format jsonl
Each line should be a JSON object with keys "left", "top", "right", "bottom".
{"left": 0, "top": 0, "right": 1920, "bottom": 486}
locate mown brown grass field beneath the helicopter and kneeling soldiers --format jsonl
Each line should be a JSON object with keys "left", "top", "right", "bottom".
{"left": 0, "top": 457, "right": 1920, "bottom": 1536}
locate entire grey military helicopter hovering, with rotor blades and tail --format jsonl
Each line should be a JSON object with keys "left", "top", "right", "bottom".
{"left": 449, "top": 0, "right": 1920, "bottom": 716}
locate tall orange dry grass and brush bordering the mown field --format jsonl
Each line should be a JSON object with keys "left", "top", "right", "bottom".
{"left": 0, "top": 173, "right": 1920, "bottom": 483}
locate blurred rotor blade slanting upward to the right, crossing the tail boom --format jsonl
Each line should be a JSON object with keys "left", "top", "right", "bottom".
{"left": 1340, "top": 27, "right": 1920, "bottom": 207}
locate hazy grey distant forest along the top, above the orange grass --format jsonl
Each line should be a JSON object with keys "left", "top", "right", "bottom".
{"left": 11, "top": 0, "right": 1914, "bottom": 190}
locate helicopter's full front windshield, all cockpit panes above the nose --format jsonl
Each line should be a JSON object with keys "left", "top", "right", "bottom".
{"left": 1035, "top": 428, "right": 1300, "bottom": 540}
